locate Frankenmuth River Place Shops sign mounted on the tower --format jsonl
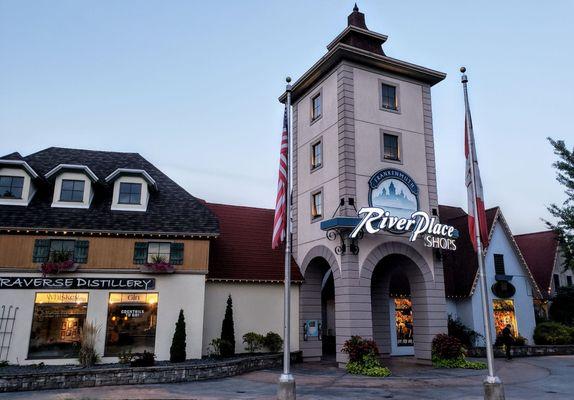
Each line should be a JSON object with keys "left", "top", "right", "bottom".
{"left": 349, "top": 168, "right": 458, "bottom": 250}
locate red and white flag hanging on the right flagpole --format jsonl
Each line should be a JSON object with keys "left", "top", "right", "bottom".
{"left": 464, "top": 113, "right": 488, "bottom": 251}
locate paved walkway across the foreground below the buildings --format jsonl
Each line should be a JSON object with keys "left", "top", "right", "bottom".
{"left": 0, "top": 356, "right": 574, "bottom": 400}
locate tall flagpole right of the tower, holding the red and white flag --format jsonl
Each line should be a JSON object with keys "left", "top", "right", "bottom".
{"left": 460, "top": 67, "right": 504, "bottom": 400}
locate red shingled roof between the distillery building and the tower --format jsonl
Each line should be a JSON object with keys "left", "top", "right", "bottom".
{"left": 206, "top": 203, "right": 303, "bottom": 282}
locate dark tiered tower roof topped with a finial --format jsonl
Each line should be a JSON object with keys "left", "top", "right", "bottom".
{"left": 279, "top": 3, "right": 446, "bottom": 103}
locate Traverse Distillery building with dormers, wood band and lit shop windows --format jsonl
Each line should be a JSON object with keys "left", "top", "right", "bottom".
{"left": 0, "top": 148, "right": 218, "bottom": 364}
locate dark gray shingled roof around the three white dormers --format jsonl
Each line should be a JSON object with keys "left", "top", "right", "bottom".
{"left": 0, "top": 147, "right": 219, "bottom": 235}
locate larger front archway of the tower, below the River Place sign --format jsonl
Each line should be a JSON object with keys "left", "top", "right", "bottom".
{"left": 361, "top": 242, "right": 447, "bottom": 360}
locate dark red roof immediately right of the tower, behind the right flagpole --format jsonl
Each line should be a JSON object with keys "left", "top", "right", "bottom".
{"left": 439, "top": 205, "right": 498, "bottom": 297}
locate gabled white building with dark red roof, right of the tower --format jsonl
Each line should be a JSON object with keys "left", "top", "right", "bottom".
{"left": 440, "top": 206, "right": 541, "bottom": 346}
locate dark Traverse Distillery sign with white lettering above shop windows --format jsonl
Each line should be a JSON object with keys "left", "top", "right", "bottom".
{"left": 0, "top": 277, "right": 155, "bottom": 290}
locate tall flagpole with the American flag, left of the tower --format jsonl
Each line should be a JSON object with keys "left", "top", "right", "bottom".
{"left": 277, "top": 77, "right": 295, "bottom": 400}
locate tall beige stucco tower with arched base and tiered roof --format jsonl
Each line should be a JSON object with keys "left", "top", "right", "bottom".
{"left": 280, "top": 6, "right": 447, "bottom": 363}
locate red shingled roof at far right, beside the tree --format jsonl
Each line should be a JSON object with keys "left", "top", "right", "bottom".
{"left": 514, "top": 231, "right": 558, "bottom": 296}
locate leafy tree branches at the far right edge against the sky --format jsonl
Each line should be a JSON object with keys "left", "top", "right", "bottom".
{"left": 546, "top": 138, "right": 574, "bottom": 270}
